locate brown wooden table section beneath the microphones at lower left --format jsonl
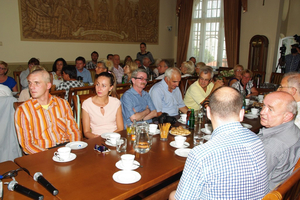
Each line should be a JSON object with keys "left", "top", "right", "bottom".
{"left": 0, "top": 161, "right": 57, "bottom": 200}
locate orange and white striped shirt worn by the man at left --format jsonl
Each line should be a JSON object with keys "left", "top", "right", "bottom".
{"left": 15, "top": 94, "right": 81, "bottom": 154}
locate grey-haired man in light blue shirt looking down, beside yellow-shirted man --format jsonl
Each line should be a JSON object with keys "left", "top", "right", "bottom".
{"left": 150, "top": 67, "right": 188, "bottom": 116}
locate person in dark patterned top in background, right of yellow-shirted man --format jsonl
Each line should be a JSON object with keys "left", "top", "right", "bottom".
{"left": 231, "top": 69, "right": 258, "bottom": 98}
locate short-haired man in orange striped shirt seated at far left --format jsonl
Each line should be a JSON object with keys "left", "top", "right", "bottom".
{"left": 15, "top": 69, "right": 81, "bottom": 154}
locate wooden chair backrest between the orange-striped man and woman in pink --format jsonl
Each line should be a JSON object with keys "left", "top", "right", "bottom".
{"left": 72, "top": 94, "right": 95, "bottom": 136}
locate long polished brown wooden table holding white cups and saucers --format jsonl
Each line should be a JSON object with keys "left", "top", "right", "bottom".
{"left": 15, "top": 116, "right": 255, "bottom": 199}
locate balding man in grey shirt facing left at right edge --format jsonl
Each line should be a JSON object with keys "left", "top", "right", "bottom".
{"left": 258, "top": 91, "right": 300, "bottom": 190}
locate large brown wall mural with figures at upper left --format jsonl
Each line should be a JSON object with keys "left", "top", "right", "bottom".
{"left": 19, "top": 0, "right": 159, "bottom": 44}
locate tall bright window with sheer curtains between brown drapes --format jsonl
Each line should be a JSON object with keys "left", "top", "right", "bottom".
{"left": 187, "top": 0, "right": 227, "bottom": 68}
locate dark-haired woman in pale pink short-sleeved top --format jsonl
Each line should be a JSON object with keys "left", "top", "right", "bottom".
{"left": 82, "top": 72, "right": 124, "bottom": 138}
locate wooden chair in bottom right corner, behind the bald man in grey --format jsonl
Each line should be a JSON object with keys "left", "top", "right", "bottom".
{"left": 263, "top": 159, "right": 300, "bottom": 200}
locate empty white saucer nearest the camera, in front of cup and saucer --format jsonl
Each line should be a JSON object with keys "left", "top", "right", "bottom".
{"left": 113, "top": 170, "right": 141, "bottom": 184}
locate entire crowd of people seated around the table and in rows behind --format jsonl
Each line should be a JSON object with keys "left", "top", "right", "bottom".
{"left": 0, "top": 43, "right": 300, "bottom": 199}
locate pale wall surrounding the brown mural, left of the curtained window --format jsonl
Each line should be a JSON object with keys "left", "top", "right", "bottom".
{"left": 0, "top": 0, "right": 177, "bottom": 63}
